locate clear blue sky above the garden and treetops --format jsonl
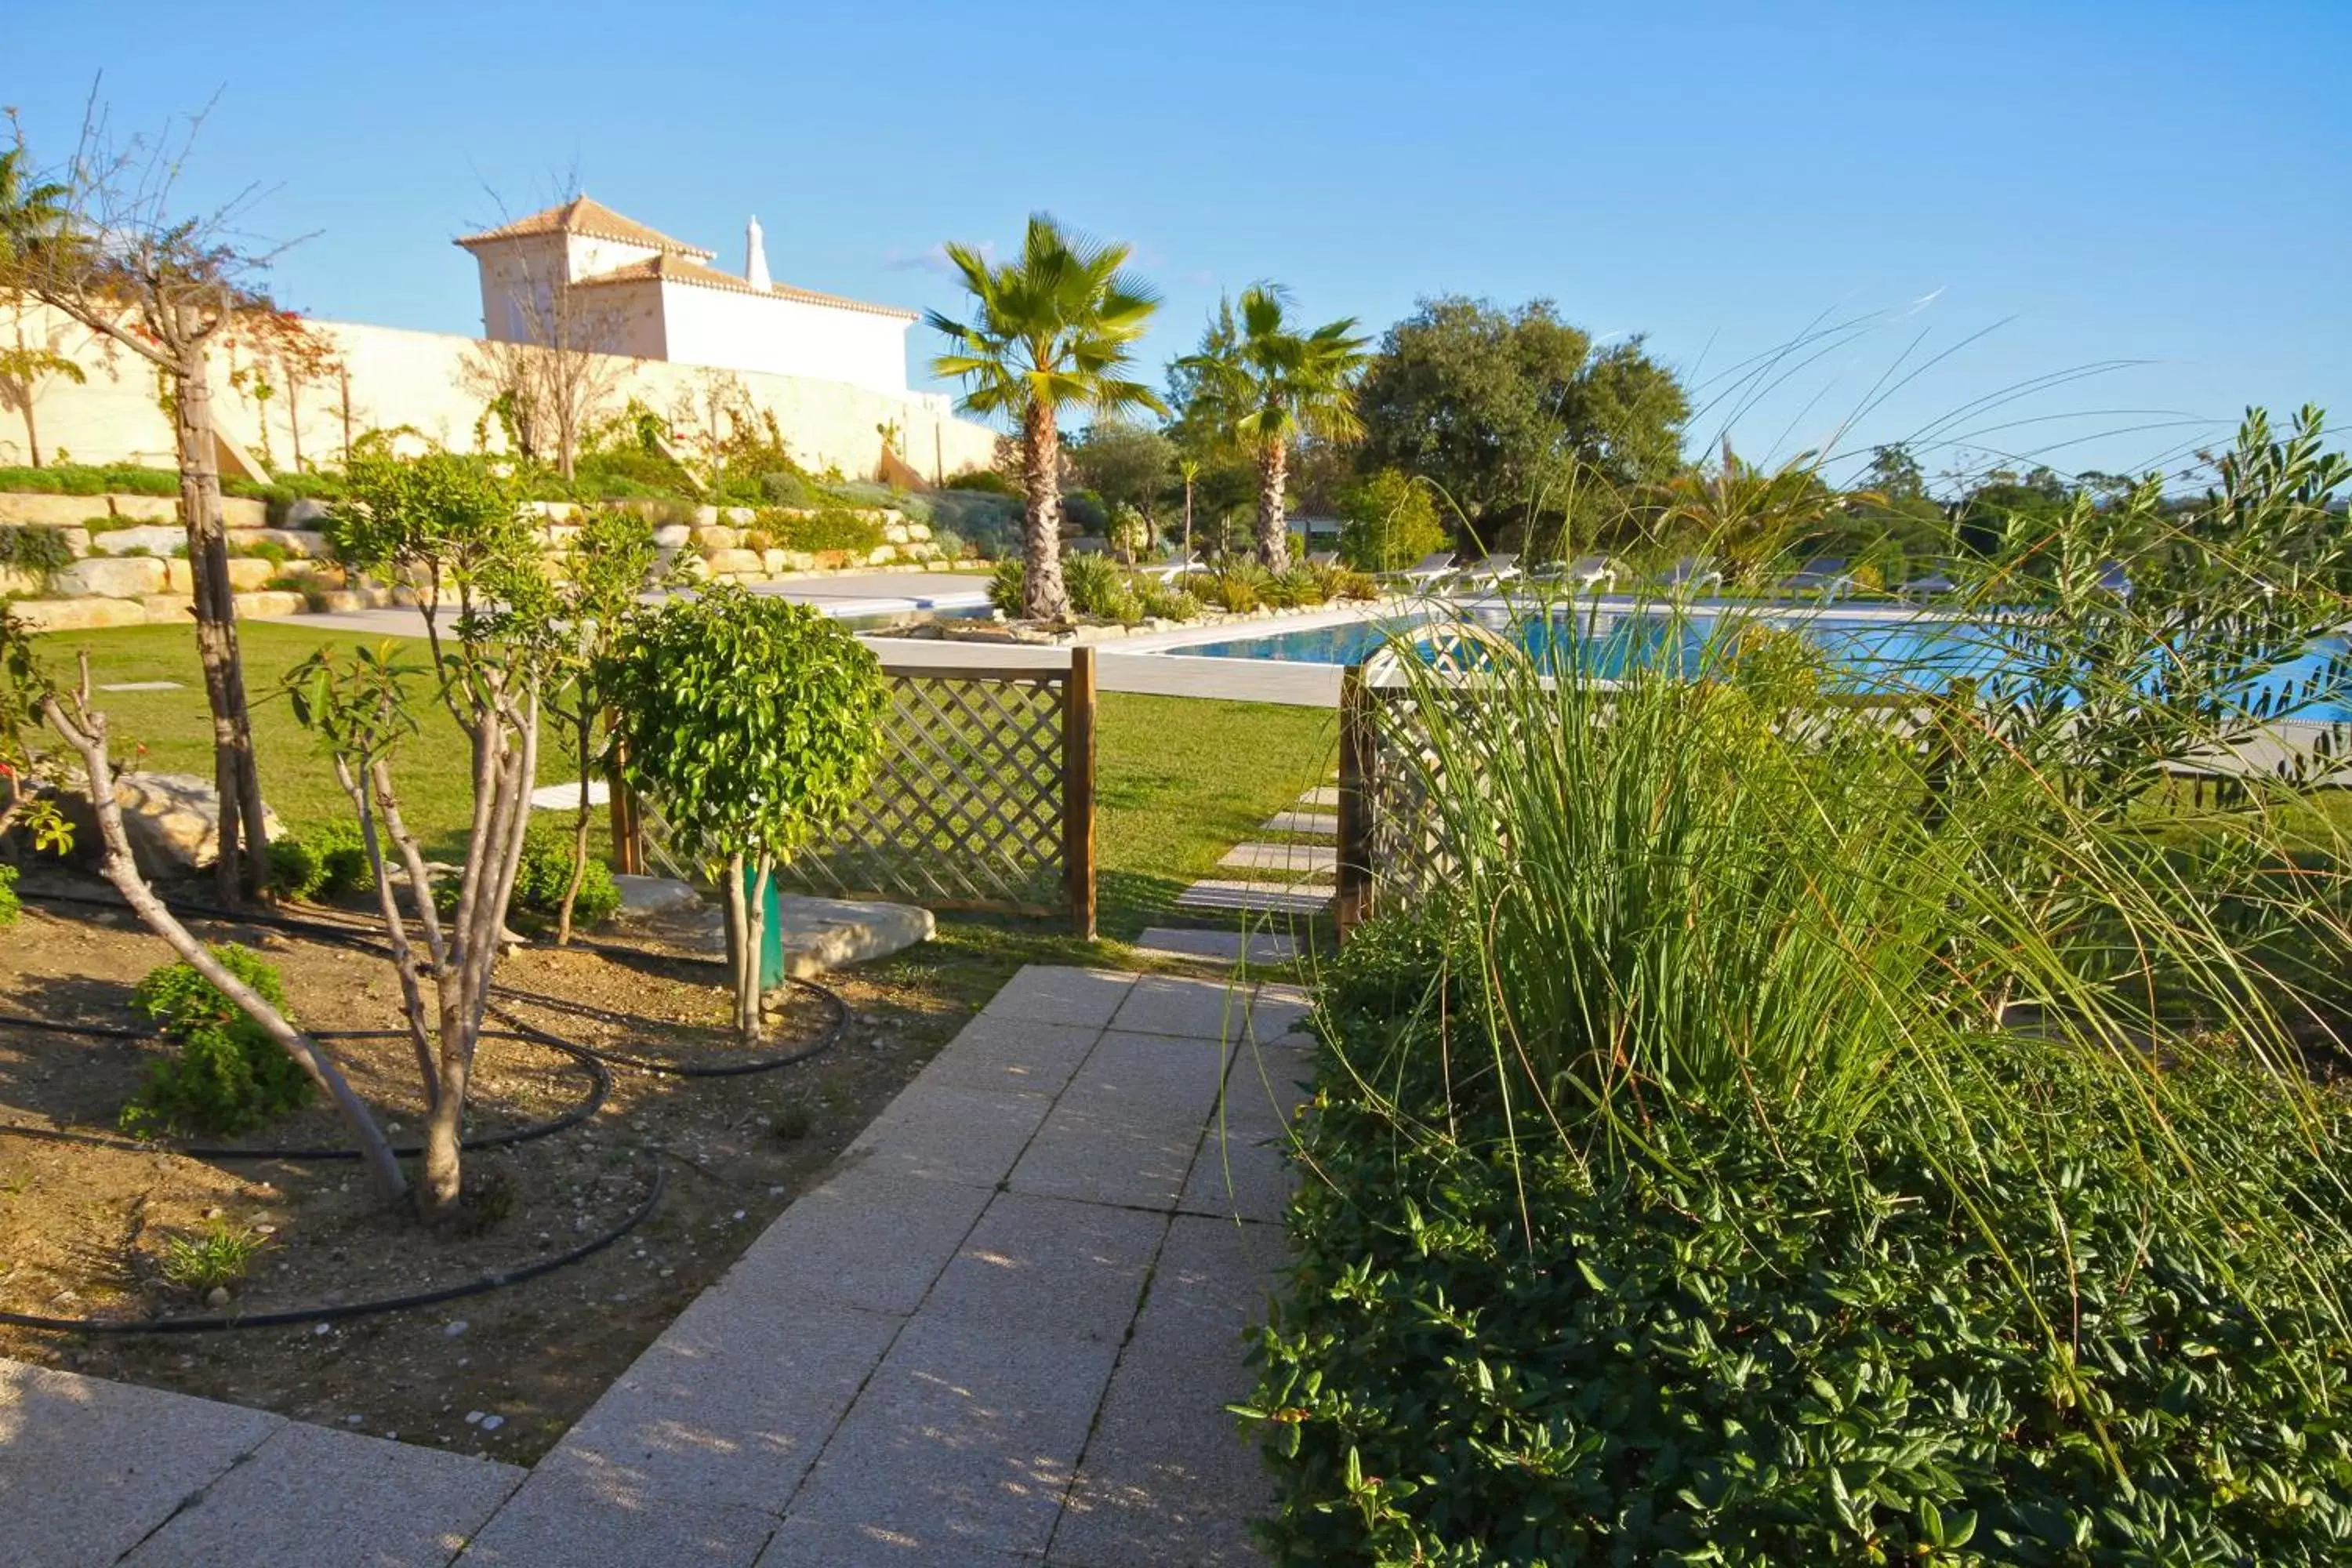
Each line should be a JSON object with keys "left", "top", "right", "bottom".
{"left": 0, "top": 0, "right": 2352, "bottom": 484}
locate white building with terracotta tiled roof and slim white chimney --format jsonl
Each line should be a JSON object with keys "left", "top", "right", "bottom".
{"left": 459, "top": 195, "right": 917, "bottom": 397}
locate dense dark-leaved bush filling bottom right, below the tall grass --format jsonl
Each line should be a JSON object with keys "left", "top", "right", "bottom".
{"left": 1254, "top": 940, "right": 2352, "bottom": 1568}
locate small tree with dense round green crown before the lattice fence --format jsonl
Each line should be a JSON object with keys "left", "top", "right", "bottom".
{"left": 612, "top": 586, "right": 889, "bottom": 1041}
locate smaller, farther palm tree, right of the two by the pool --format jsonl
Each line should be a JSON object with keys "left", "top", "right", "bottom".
{"left": 1181, "top": 282, "right": 1369, "bottom": 572}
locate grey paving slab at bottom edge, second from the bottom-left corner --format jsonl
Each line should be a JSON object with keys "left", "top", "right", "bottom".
{"left": 122, "top": 1422, "right": 529, "bottom": 1568}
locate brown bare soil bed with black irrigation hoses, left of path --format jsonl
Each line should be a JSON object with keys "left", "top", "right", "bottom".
{"left": 0, "top": 884, "right": 967, "bottom": 1465}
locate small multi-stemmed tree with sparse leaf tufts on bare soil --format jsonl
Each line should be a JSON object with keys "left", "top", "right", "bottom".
{"left": 287, "top": 452, "right": 548, "bottom": 1218}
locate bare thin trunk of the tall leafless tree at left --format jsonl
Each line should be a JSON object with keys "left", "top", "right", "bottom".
{"left": 172, "top": 343, "right": 270, "bottom": 902}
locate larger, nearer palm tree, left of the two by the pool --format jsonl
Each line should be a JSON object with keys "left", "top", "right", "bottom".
{"left": 929, "top": 212, "right": 1167, "bottom": 621}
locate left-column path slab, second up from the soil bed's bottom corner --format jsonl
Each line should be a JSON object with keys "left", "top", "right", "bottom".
{"left": 717, "top": 1163, "right": 990, "bottom": 1316}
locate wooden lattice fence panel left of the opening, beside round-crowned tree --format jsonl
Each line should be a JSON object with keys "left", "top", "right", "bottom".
{"left": 779, "top": 670, "right": 1068, "bottom": 912}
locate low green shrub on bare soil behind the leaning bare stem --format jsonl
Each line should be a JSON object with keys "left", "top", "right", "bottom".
{"left": 122, "top": 945, "right": 310, "bottom": 1135}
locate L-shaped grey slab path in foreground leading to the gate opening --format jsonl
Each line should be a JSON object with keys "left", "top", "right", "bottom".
{"left": 0, "top": 966, "right": 1308, "bottom": 1568}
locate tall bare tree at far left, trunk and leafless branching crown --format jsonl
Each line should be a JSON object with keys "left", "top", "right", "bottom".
{"left": 0, "top": 99, "right": 289, "bottom": 898}
